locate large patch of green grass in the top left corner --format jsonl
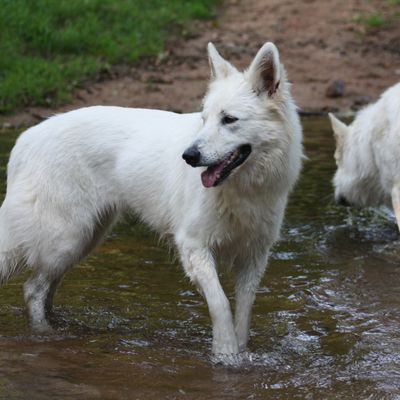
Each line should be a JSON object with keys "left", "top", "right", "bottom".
{"left": 0, "top": 0, "right": 219, "bottom": 113}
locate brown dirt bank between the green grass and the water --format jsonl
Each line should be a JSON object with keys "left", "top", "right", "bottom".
{"left": 3, "top": 0, "right": 400, "bottom": 126}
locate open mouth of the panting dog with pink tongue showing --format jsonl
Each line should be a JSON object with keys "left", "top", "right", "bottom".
{"left": 201, "top": 144, "right": 251, "bottom": 187}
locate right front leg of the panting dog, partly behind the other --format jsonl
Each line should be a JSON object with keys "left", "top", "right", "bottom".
{"left": 235, "top": 254, "right": 268, "bottom": 351}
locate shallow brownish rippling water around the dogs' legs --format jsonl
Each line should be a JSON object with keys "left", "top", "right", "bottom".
{"left": 0, "top": 119, "right": 400, "bottom": 400}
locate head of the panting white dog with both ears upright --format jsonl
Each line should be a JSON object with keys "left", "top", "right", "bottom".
{"left": 182, "top": 43, "right": 294, "bottom": 187}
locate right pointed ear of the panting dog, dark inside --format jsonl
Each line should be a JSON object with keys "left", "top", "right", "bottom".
{"left": 247, "top": 42, "right": 281, "bottom": 97}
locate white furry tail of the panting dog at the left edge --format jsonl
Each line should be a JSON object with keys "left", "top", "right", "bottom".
{"left": 0, "top": 204, "right": 24, "bottom": 285}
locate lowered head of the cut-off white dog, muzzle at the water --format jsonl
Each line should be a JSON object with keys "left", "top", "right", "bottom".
{"left": 329, "top": 114, "right": 382, "bottom": 206}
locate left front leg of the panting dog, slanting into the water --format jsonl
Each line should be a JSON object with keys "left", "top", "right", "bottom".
{"left": 178, "top": 244, "right": 239, "bottom": 355}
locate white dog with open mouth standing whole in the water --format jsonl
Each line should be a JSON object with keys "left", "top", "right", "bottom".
{"left": 0, "top": 43, "right": 302, "bottom": 354}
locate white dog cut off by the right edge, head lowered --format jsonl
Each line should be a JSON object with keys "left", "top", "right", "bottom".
{"left": 329, "top": 83, "right": 400, "bottom": 228}
